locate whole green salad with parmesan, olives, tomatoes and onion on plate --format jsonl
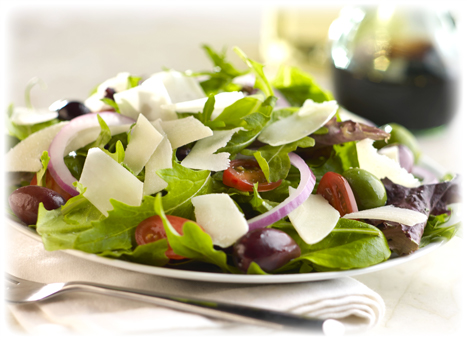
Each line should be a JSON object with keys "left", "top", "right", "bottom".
{"left": 6, "top": 46, "right": 460, "bottom": 275}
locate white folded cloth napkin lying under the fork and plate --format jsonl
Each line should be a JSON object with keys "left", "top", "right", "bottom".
{"left": 6, "top": 224, "right": 385, "bottom": 335}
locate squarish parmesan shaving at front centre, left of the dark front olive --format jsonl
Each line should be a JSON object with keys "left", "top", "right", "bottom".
{"left": 191, "top": 194, "right": 248, "bottom": 248}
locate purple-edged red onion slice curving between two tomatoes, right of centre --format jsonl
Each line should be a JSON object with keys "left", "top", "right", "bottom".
{"left": 247, "top": 152, "right": 316, "bottom": 230}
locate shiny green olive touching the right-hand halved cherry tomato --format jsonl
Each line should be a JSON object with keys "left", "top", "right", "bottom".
{"left": 342, "top": 168, "right": 387, "bottom": 210}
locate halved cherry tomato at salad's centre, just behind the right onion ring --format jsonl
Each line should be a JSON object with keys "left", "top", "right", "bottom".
{"left": 222, "top": 159, "right": 282, "bottom": 192}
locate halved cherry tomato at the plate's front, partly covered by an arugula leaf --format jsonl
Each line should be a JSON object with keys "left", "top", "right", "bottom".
{"left": 135, "top": 215, "right": 202, "bottom": 260}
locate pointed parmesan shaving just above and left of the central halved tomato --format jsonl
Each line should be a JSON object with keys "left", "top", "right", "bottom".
{"left": 181, "top": 128, "right": 242, "bottom": 171}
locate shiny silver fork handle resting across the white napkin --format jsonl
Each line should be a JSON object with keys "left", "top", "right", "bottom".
{"left": 62, "top": 282, "right": 344, "bottom": 334}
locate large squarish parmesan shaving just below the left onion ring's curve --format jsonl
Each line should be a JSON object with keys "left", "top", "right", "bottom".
{"left": 79, "top": 148, "right": 143, "bottom": 216}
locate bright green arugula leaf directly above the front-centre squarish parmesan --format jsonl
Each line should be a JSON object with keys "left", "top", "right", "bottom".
{"left": 157, "top": 160, "right": 212, "bottom": 220}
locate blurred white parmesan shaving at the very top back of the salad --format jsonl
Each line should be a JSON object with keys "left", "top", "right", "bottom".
{"left": 142, "top": 70, "right": 206, "bottom": 103}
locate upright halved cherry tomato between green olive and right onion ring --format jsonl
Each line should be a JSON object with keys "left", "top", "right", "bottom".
{"left": 317, "top": 172, "right": 358, "bottom": 217}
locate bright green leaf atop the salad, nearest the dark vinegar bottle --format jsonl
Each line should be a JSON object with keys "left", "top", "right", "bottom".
{"left": 272, "top": 65, "right": 333, "bottom": 107}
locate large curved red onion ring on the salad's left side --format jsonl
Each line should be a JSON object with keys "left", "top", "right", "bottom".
{"left": 47, "top": 112, "right": 135, "bottom": 196}
